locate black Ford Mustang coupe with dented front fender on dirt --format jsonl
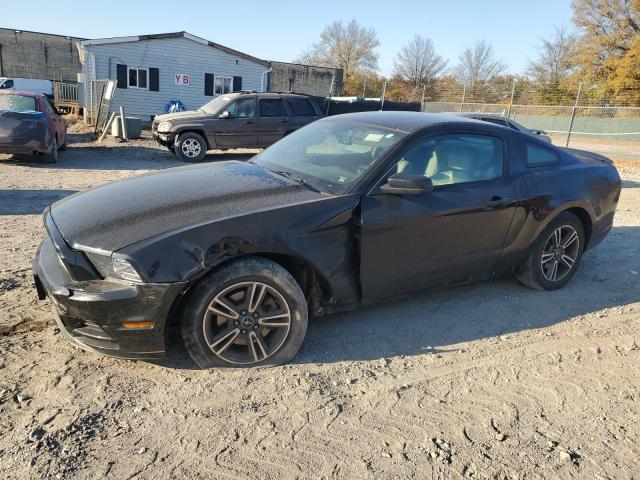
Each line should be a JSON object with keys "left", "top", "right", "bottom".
{"left": 34, "top": 112, "right": 620, "bottom": 367}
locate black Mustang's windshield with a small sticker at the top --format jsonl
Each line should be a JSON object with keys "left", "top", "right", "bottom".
{"left": 254, "top": 118, "right": 405, "bottom": 193}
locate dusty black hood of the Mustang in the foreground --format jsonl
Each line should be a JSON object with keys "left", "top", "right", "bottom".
{"left": 51, "top": 161, "right": 327, "bottom": 252}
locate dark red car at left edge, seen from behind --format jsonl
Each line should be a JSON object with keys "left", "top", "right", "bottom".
{"left": 0, "top": 91, "right": 67, "bottom": 163}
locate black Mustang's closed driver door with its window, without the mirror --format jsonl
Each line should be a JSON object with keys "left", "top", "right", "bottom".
{"left": 360, "top": 132, "right": 516, "bottom": 300}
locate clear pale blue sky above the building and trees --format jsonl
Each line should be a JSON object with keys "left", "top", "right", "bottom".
{"left": 0, "top": 0, "right": 572, "bottom": 75}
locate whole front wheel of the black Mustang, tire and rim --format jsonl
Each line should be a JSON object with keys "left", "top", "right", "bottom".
{"left": 181, "top": 257, "right": 308, "bottom": 368}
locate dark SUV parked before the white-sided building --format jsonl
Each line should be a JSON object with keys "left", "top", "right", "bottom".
{"left": 151, "top": 92, "right": 323, "bottom": 161}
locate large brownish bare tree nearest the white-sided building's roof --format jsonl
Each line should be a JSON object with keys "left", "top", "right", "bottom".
{"left": 296, "top": 20, "right": 380, "bottom": 78}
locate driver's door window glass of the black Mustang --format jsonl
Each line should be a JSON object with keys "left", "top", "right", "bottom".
{"left": 392, "top": 134, "right": 504, "bottom": 186}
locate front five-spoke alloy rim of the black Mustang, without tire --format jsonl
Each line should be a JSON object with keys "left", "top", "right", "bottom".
{"left": 202, "top": 282, "right": 291, "bottom": 365}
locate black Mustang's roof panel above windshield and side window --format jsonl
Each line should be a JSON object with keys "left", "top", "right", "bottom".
{"left": 329, "top": 111, "right": 484, "bottom": 132}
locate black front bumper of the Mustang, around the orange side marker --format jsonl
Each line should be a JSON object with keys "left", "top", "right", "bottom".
{"left": 33, "top": 236, "right": 185, "bottom": 359}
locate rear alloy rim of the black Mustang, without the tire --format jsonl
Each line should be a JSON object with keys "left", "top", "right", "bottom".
{"left": 540, "top": 225, "right": 580, "bottom": 282}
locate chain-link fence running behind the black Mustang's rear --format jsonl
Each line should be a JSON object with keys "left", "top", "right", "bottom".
{"left": 422, "top": 79, "right": 640, "bottom": 161}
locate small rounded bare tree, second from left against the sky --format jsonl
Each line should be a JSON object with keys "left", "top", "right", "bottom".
{"left": 393, "top": 35, "right": 447, "bottom": 87}
